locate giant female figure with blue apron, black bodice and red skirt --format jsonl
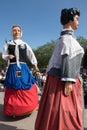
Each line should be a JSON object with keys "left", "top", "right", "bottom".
{"left": 2, "top": 25, "right": 39, "bottom": 116}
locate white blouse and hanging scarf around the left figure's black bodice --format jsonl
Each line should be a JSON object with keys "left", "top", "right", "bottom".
{"left": 2, "top": 39, "right": 37, "bottom": 66}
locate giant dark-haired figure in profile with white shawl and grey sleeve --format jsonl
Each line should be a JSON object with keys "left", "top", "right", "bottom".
{"left": 35, "top": 8, "right": 84, "bottom": 130}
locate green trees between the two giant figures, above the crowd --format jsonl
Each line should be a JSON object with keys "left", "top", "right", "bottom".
{"left": 33, "top": 41, "right": 55, "bottom": 68}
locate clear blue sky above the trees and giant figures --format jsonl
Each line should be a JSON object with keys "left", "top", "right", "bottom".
{"left": 0, "top": 0, "right": 87, "bottom": 52}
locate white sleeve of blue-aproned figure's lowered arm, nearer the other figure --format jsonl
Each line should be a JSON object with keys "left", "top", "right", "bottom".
{"left": 26, "top": 43, "right": 37, "bottom": 65}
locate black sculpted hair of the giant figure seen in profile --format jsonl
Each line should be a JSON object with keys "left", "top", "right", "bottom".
{"left": 60, "top": 8, "right": 80, "bottom": 25}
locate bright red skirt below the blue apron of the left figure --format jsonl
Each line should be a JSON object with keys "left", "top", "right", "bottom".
{"left": 4, "top": 84, "right": 38, "bottom": 116}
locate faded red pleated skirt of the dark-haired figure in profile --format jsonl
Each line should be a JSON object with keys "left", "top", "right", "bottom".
{"left": 35, "top": 75, "right": 83, "bottom": 130}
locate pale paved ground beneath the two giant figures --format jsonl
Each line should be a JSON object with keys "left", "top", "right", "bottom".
{"left": 0, "top": 92, "right": 87, "bottom": 130}
